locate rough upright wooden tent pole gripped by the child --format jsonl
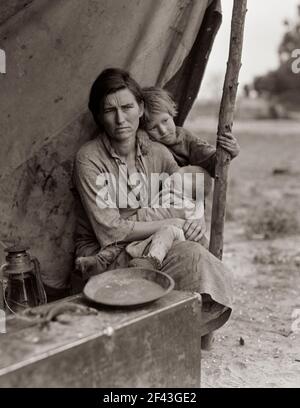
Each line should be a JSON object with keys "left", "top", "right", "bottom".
{"left": 209, "top": 0, "right": 247, "bottom": 259}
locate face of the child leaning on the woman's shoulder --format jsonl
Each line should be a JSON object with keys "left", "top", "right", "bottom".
{"left": 146, "top": 112, "right": 176, "bottom": 146}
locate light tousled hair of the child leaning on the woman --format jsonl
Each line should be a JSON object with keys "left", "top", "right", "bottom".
{"left": 142, "top": 86, "right": 177, "bottom": 121}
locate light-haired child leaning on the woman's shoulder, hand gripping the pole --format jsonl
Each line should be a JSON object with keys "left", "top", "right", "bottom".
{"left": 142, "top": 87, "right": 240, "bottom": 177}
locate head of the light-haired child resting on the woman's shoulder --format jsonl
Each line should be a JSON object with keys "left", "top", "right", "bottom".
{"left": 143, "top": 86, "right": 177, "bottom": 145}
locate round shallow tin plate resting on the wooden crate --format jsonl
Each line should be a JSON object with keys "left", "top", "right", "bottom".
{"left": 83, "top": 268, "right": 174, "bottom": 306}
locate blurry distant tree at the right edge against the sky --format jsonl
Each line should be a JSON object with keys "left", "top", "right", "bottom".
{"left": 253, "top": 4, "right": 300, "bottom": 110}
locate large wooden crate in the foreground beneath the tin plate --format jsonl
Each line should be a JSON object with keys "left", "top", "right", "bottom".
{"left": 0, "top": 291, "right": 201, "bottom": 388}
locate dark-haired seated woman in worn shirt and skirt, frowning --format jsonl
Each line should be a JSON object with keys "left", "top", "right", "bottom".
{"left": 74, "top": 69, "right": 231, "bottom": 350}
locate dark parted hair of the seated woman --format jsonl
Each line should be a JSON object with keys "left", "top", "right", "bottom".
{"left": 88, "top": 68, "right": 143, "bottom": 130}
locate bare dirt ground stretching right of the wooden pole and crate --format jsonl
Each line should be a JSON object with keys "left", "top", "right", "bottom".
{"left": 187, "top": 118, "right": 300, "bottom": 388}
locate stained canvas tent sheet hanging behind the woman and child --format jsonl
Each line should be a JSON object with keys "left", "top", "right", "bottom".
{"left": 0, "top": 0, "right": 221, "bottom": 288}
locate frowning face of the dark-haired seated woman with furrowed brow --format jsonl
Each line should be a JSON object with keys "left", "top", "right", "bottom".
{"left": 100, "top": 88, "right": 144, "bottom": 142}
